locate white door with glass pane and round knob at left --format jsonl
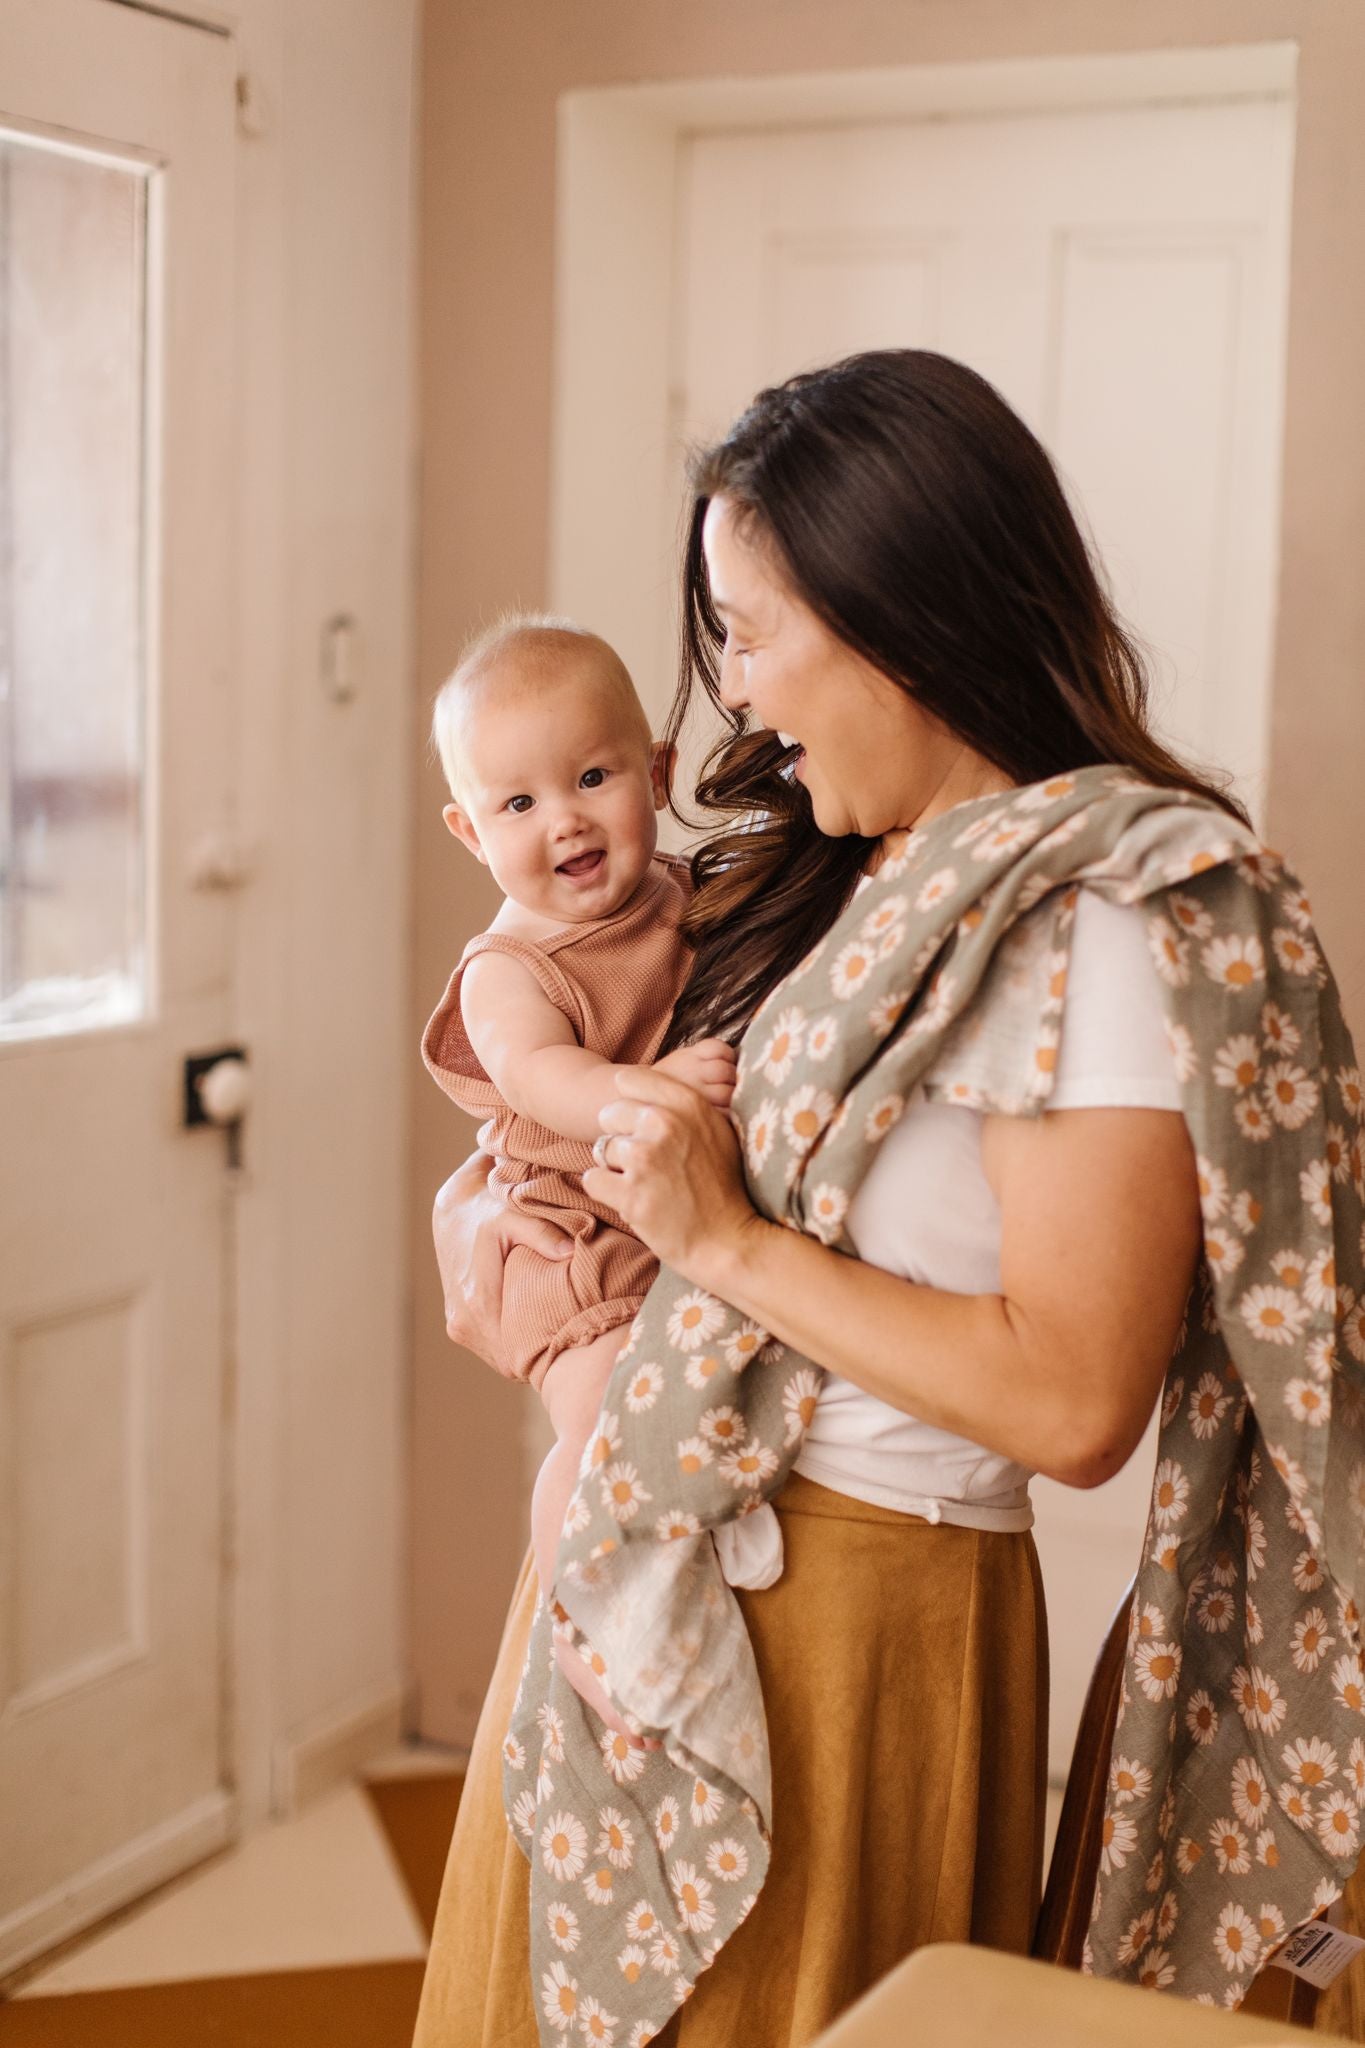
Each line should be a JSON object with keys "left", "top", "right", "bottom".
{"left": 0, "top": 0, "right": 237, "bottom": 1968}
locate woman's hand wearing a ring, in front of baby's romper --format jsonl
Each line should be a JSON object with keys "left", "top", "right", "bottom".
{"left": 583, "top": 1067, "right": 761, "bottom": 1286}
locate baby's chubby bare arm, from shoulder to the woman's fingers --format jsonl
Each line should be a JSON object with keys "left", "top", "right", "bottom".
{"left": 460, "top": 952, "right": 616, "bottom": 1145}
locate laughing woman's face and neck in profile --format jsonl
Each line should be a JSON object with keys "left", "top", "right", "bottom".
{"left": 702, "top": 496, "right": 1009, "bottom": 840}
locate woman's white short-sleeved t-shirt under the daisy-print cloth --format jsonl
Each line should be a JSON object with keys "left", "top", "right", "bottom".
{"left": 796, "top": 889, "right": 1181, "bottom": 1530}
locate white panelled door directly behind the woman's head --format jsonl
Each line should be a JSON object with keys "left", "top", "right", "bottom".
{"left": 669, "top": 98, "right": 1293, "bottom": 1778}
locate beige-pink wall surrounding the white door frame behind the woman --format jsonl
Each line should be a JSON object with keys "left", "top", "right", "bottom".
{"left": 413, "top": 0, "right": 1365, "bottom": 1741}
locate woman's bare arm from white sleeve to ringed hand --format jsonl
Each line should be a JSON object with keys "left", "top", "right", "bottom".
{"left": 589, "top": 1073, "right": 1199, "bottom": 1487}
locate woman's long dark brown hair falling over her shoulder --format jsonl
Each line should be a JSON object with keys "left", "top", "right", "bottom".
{"left": 667, "top": 348, "right": 1244, "bottom": 1047}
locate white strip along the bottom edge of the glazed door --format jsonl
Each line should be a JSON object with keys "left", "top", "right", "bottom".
{"left": 0, "top": 1792, "right": 237, "bottom": 1972}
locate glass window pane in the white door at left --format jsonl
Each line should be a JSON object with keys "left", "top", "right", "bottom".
{"left": 0, "top": 133, "right": 147, "bottom": 1038}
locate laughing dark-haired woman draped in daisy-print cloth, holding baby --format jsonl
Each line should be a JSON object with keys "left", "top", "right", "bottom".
{"left": 417, "top": 352, "right": 1365, "bottom": 2048}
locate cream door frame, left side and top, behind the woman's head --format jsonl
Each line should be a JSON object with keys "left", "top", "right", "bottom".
{"left": 546, "top": 41, "right": 1297, "bottom": 745}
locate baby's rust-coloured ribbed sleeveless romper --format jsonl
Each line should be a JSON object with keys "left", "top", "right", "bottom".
{"left": 422, "top": 854, "right": 692, "bottom": 1386}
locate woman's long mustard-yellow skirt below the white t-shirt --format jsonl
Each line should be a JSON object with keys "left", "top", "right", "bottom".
{"left": 413, "top": 1477, "right": 1048, "bottom": 2048}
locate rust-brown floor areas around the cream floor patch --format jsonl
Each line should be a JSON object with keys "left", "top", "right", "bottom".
{"left": 0, "top": 1774, "right": 463, "bottom": 2048}
